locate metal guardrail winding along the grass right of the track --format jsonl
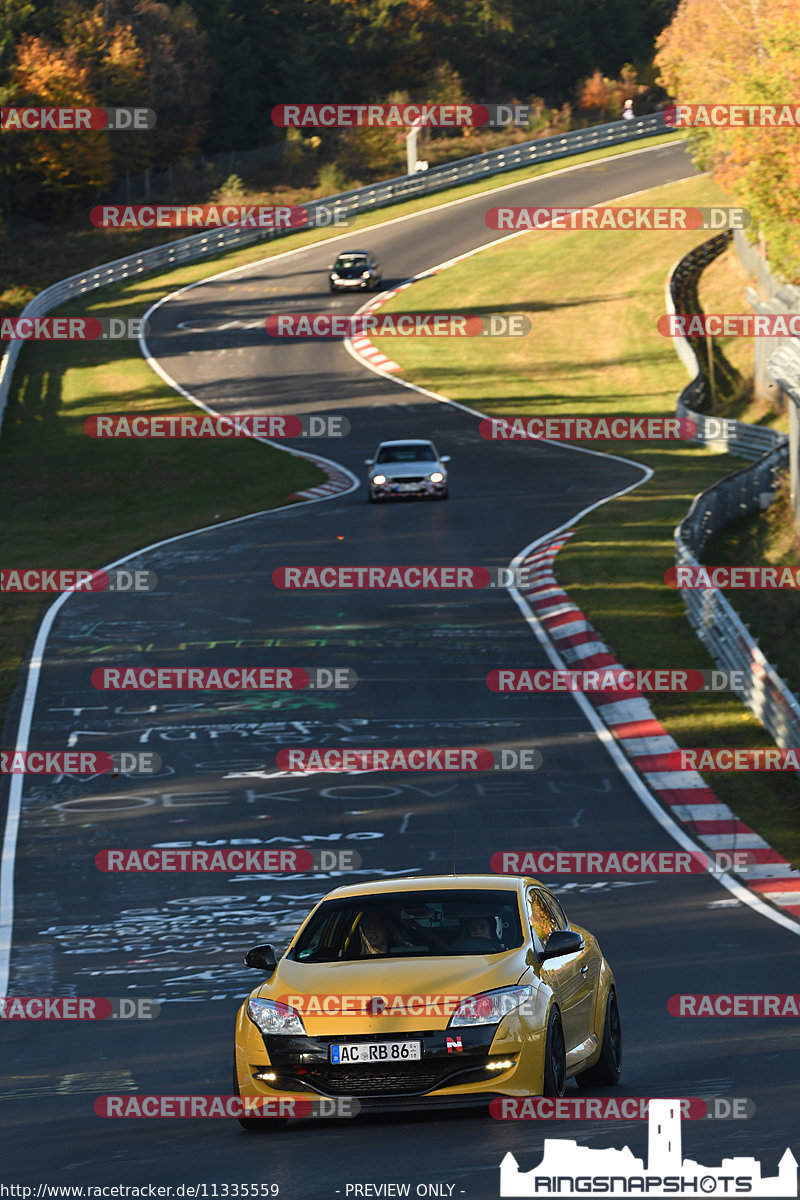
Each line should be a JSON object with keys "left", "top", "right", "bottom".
{"left": 667, "top": 234, "right": 800, "bottom": 748}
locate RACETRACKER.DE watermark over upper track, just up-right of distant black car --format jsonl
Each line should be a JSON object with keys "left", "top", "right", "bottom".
{"left": 483, "top": 206, "right": 751, "bottom": 232}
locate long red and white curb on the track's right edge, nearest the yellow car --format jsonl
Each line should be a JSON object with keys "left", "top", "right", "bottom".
{"left": 519, "top": 529, "right": 800, "bottom": 917}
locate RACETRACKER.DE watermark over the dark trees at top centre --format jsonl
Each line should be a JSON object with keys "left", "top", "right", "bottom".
{"left": 271, "top": 103, "right": 530, "bottom": 130}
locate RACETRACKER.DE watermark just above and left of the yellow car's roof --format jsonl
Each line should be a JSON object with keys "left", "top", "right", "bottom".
{"left": 95, "top": 846, "right": 362, "bottom": 875}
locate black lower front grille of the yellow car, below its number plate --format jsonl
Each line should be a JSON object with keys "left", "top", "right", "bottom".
{"left": 287, "top": 1054, "right": 486, "bottom": 1096}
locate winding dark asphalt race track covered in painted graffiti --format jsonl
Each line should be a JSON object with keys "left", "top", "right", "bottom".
{"left": 0, "top": 144, "right": 800, "bottom": 1200}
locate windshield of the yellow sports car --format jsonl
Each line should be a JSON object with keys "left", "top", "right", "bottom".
{"left": 291, "top": 889, "right": 523, "bottom": 962}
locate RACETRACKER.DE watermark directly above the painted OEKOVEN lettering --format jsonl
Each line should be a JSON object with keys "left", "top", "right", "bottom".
{"left": 276, "top": 746, "right": 542, "bottom": 774}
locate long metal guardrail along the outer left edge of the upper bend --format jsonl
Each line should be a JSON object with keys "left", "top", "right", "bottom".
{"left": 0, "top": 113, "right": 673, "bottom": 427}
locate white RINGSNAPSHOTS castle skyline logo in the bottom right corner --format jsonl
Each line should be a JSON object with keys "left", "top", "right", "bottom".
{"left": 500, "top": 1099, "right": 798, "bottom": 1200}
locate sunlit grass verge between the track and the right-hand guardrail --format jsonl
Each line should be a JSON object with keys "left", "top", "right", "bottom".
{"left": 374, "top": 171, "right": 800, "bottom": 862}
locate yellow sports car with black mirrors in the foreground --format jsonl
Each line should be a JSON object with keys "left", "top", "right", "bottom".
{"left": 234, "top": 875, "right": 621, "bottom": 1129}
